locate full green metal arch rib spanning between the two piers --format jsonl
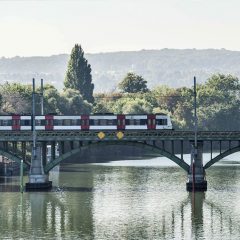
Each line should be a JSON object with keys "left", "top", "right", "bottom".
{"left": 44, "top": 141, "right": 190, "bottom": 173}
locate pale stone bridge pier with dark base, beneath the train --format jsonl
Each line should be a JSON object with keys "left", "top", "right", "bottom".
{"left": 26, "top": 144, "right": 52, "bottom": 191}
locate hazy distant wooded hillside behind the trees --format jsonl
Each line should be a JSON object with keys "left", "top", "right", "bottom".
{"left": 0, "top": 49, "right": 240, "bottom": 92}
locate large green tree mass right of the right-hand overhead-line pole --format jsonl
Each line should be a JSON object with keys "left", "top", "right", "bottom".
{"left": 198, "top": 74, "right": 240, "bottom": 131}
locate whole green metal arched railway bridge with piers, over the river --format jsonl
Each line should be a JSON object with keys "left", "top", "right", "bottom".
{"left": 0, "top": 130, "right": 240, "bottom": 191}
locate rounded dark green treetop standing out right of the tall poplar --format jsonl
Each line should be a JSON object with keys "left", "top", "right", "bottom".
{"left": 118, "top": 72, "right": 148, "bottom": 93}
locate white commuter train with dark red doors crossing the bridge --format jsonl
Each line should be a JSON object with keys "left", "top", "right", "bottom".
{"left": 0, "top": 114, "right": 172, "bottom": 131}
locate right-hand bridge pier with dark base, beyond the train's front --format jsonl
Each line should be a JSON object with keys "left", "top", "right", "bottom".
{"left": 186, "top": 141, "right": 207, "bottom": 192}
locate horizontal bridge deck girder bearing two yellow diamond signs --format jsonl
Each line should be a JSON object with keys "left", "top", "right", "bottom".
{"left": 0, "top": 130, "right": 240, "bottom": 142}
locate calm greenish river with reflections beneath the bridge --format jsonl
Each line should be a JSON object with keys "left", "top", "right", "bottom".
{"left": 0, "top": 154, "right": 240, "bottom": 240}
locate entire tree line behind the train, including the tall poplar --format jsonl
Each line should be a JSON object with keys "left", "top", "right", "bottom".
{"left": 0, "top": 45, "right": 240, "bottom": 130}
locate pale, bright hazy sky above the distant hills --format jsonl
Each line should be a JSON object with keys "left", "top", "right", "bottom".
{"left": 0, "top": 0, "right": 240, "bottom": 57}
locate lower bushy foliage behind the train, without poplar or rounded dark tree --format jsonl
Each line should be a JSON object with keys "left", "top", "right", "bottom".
{"left": 0, "top": 74, "right": 240, "bottom": 131}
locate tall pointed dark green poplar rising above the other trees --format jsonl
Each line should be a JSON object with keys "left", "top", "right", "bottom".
{"left": 64, "top": 44, "right": 94, "bottom": 103}
